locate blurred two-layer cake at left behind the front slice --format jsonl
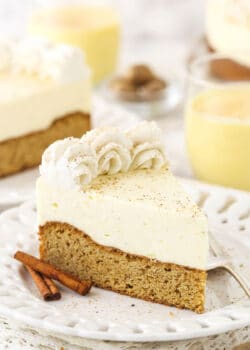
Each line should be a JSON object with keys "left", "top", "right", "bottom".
{"left": 0, "top": 38, "right": 91, "bottom": 177}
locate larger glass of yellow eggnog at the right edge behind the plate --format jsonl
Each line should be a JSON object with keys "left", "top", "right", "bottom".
{"left": 185, "top": 54, "right": 250, "bottom": 191}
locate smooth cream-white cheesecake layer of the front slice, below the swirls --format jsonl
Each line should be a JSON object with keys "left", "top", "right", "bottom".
{"left": 37, "top": 169, "right": 208, "bottom": 269}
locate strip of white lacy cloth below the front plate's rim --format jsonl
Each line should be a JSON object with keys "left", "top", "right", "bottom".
{"left": 0, "top": 319, "right": 250, "bottom": 350}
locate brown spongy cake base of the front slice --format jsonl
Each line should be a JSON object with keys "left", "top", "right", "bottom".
{"left": 39, "top": 222, "right": 206, "bottom": 313}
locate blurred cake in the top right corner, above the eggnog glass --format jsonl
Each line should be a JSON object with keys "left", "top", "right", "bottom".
{"left": 206, "top": 0, "right": 250, "bottom": 80}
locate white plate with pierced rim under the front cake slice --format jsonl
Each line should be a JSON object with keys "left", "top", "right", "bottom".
{"left": 0, "top": 180, "right": 250, "bottom": 342}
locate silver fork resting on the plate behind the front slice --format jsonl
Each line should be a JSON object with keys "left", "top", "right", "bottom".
{"left": 206, "top": 232, "right": 250, "bottom": 298}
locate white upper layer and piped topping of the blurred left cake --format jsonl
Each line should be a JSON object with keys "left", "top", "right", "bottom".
{"left": 0, "top": 39, "right": 91, "bottom": 142}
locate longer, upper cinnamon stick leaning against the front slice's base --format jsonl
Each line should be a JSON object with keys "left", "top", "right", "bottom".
{"left": 14, "top": 251, "right": 92, "bottom": 295}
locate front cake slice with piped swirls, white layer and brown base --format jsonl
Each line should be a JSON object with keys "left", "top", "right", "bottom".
{"left": 37, "top": 122, "right": 208, "bottom": 312}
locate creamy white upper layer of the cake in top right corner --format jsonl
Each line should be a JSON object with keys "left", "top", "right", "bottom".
{"left": 206, "top": 0, "right": 250, "bottom": 66}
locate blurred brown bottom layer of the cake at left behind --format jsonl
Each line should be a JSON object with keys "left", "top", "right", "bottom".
{"left": 0, "top": 112, "right": 90, "bottom": 177}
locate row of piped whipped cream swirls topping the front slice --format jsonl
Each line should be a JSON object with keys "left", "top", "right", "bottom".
{"left": 40, "top": 122, "right": 167, "bottom": 188}
